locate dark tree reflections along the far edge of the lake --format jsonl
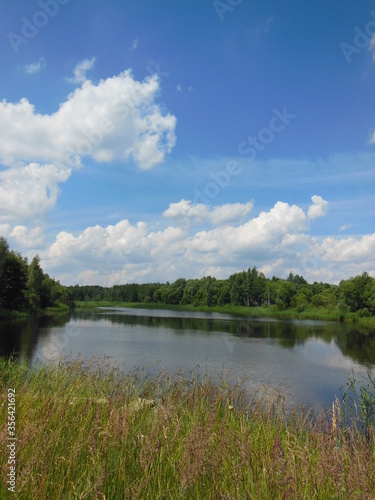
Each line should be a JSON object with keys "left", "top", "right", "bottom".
{"left": 0, "top": 311, "right": 375, "bottom": 365}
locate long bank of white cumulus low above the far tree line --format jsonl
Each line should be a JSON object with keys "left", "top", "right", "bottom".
{"left": 43, "top": 200, "right": 312, "bottom": 284}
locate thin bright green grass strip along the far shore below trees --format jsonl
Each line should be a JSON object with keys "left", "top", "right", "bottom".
{"left": 74, "top": 301, "right": 375, "bottom": 328}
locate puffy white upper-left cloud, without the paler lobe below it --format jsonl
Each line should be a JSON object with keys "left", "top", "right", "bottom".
{"left": 0, "top": 71, "right": 176, "bottom": 169}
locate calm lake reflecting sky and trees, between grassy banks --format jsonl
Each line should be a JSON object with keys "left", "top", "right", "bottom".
{"left": 0, "top": 308, "right": 375, "bottom": 410}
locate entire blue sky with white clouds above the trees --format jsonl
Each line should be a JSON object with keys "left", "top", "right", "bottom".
{"left": 0, "top": 0, "right": 375, "bottom": 285}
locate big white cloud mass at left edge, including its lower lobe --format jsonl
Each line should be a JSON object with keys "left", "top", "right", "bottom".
{"left": 0, "top": 71, "right": 176, "bottom": 223}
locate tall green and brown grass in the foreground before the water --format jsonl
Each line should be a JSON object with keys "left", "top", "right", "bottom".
{"left": 0, "top": 360, "right": 375, "bottom": 499}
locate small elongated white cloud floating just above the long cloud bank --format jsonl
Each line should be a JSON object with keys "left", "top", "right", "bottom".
{"left": 163, "top": 199, "right": 253, "bottom": 225}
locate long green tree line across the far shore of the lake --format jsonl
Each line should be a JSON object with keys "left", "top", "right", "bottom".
{"left": 68, "top": 267, "right": 375, "bottom": 316}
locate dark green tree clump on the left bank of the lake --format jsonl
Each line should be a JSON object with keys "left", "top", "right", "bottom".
{"left": 0, "top": 237, "right": 73, "bottom": 313}
